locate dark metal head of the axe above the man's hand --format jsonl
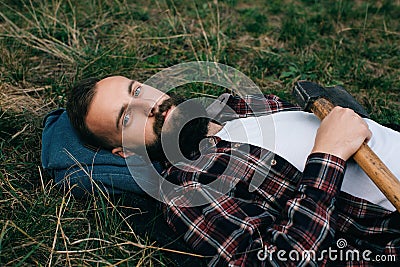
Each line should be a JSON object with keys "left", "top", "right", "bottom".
{"left": 293, "top": 81, "right": 369, "bottom": 118}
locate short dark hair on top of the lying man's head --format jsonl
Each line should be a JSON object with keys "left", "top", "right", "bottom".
{"left": 67, "top": 77, "right": 112, "bottom": 149}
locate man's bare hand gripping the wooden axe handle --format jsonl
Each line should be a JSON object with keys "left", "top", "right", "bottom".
{"left": 312, "top": 107, "right": 372, "bottom": 160}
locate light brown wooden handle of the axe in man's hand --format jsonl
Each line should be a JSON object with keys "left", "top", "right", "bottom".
{"left": 311, "top": 98, "right": 400, "bottom": 212}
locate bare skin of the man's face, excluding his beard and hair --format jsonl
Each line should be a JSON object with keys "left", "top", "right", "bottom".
{"left": 86, "top": 76, "right": 173, "bottom": 156}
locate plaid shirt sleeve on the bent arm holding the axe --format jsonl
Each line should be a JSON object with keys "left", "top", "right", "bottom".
{"left": 164, "top": 153, "right": 345, "bottom": 266}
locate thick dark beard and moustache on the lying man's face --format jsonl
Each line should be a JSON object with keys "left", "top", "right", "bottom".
{"left": 146, "top": 95, "right": 210, "bottom": 162}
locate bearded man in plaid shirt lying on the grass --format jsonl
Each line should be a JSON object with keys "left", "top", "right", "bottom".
{"left": 67, "top": 76, "right": 400, "bottom": 266}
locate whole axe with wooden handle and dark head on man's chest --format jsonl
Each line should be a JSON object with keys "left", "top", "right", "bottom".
{"left": 293, "top": 81, "right": 400, "bottom": 212}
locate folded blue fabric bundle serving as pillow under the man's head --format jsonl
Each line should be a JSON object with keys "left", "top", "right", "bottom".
{"left": 41, "top": 109, "right": 161, "bottom": 197}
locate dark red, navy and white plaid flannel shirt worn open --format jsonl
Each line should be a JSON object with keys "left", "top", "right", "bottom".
{"left": 162, "top": 95, "right": 400, "bottom": 266}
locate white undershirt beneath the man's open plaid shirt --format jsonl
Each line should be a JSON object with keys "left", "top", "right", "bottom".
{"left": 216, "top": 111, "right": 400, "bottom": 211}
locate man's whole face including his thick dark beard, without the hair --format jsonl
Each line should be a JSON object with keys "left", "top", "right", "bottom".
{"left": 86, "top": 76, "right": 209, "bottom": 161}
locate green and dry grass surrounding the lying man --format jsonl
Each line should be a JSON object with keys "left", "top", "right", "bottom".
{"left": 0, "top": 0, "right": 400, "bottom": 266}
